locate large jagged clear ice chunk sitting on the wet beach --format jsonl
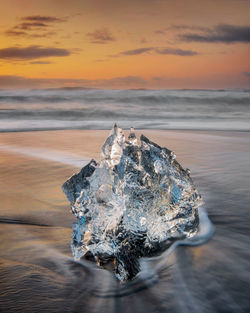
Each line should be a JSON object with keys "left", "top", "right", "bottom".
{"left": 63, "top": 125, "right": 202, "bottom": 281}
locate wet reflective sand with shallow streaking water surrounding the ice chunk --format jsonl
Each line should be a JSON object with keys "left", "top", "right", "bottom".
{"left": 0, "top": 130, "right": 250, "bottom": 313}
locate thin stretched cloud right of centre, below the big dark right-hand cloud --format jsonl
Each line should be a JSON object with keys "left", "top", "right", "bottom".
{"left": 111, "top": 47, "right": 198, "bottom": 58}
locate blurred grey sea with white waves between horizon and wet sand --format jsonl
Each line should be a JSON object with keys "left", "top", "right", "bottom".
{"left": 0, "top": 88, "right": 250, "bottom": 131}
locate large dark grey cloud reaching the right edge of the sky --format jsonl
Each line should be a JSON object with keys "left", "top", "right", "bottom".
{"left": 179, "top": 24, "right": 250, "bottom": 44}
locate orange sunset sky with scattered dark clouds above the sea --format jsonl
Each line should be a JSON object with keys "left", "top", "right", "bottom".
{"left": 0, "top": 0, "right": 250, "bottom": 89}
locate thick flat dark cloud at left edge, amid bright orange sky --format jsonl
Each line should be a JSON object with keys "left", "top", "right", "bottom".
{"left": 0, "top": 46, "right": 71, "bottom": 61}
